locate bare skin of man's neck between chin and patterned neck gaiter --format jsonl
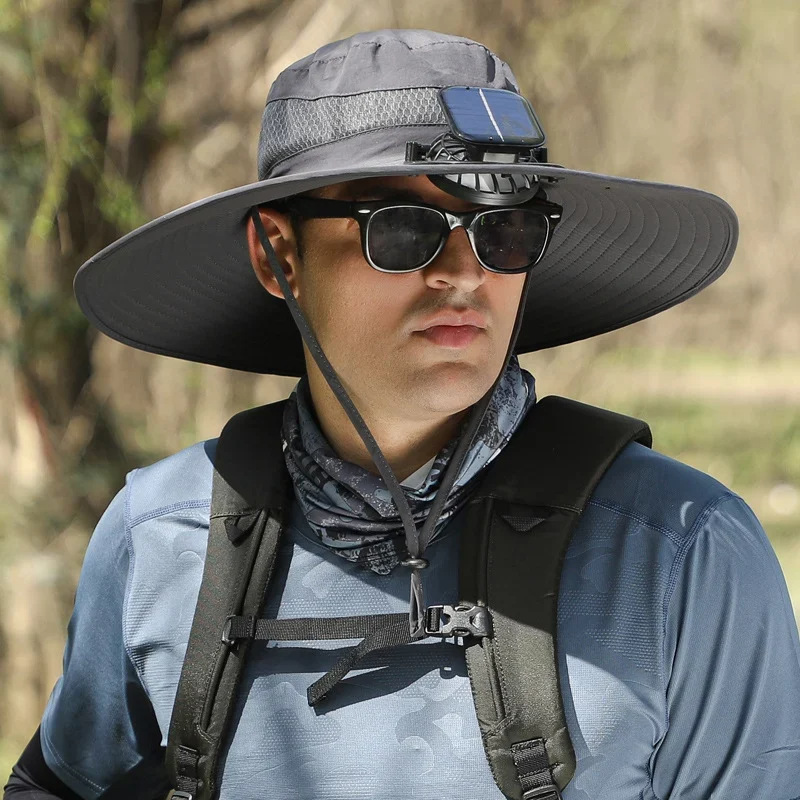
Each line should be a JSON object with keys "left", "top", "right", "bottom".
{"left": 309, "top": 370, "right": 469, "bottom": 482}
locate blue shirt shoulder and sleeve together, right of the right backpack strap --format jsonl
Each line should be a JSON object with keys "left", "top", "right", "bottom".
{"left": 558, "top": 444, "right": 800, "bottom": 800}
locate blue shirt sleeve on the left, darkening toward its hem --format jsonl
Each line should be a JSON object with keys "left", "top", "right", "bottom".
{"left": 40, "top": 482, "right": 169, "bottom": 800}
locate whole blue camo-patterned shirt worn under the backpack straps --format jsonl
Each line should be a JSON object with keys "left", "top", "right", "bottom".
{"left": 41, "top": 442, "right": 800, "bottom": 800}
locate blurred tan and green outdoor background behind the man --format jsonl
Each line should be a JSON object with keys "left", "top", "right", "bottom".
{"left": 0, "top": 0, "right": 800, "bottom": 780}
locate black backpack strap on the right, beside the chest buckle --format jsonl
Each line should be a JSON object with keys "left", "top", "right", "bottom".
{"left": 459, "top": 397, "right": 652, "bottom": 800}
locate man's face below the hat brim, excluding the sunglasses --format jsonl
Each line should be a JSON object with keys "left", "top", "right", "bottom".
{"left": 253, "top": 176, "right": 525, "bottom": 420}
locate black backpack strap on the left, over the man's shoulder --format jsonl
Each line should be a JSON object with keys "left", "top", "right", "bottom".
{"left": 165, "top": 401, "right": 291, "bottom": 800}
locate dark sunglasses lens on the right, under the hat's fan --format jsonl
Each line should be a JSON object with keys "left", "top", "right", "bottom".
{"left": 474, "top": 208, "right": 548, "bottom": 272}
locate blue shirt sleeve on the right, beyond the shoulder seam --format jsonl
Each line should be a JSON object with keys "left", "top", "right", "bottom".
{"left": 651, "top": 496, "right": 800, "bottom": 800}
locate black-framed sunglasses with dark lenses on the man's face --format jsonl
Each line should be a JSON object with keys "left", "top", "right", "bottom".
{"left": 280, "top": 196, "right": 562, "bottom": 274}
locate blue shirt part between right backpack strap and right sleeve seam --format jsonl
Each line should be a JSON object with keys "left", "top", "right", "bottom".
{"left": 558, "top": 444, "right": 729, "bottom": 780}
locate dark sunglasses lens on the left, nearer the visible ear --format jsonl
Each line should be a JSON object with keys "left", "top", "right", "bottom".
{"left": 367, "top": 206, "right": 444, "bottom": 272}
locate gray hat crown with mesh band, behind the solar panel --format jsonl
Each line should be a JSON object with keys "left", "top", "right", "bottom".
{"left": 258, "top": 30, "right": 519, "bottom": 180}
